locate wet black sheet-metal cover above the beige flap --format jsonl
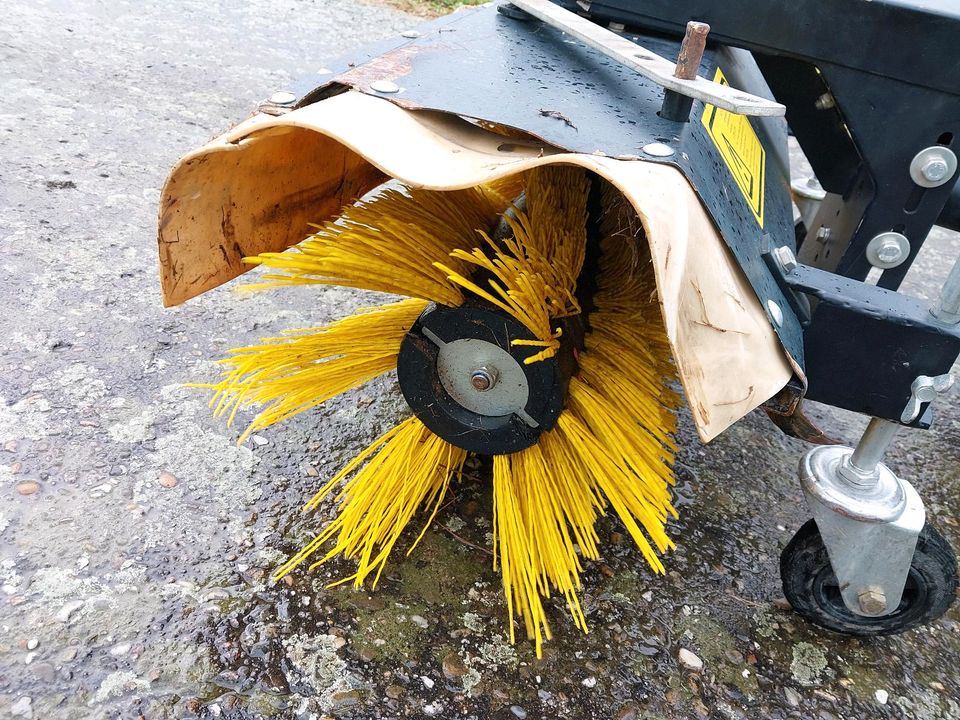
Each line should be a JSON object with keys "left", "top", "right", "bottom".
{"left": 301, "top": 1, "right": 803, "bottom": 367}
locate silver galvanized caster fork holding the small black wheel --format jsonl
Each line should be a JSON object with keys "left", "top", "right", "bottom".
{"left": 800, "top": 445, "right": 926, "bottom": 617}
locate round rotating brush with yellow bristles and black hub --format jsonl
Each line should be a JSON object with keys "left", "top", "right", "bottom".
{"left": 210, "top": 166, "right": 679, "bottom": 656}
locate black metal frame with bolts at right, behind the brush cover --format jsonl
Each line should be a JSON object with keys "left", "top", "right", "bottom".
{"left": 561, "top": 0, "right": 960, "bottom": 424}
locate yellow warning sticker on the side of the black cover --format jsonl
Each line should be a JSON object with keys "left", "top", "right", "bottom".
{"left": 702, "top": 68, "right": 767, "bottom": 227}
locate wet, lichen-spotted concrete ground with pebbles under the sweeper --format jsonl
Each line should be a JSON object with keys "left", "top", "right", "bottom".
{"left": 0, "top": 0, "right": 960, "bottom": 720}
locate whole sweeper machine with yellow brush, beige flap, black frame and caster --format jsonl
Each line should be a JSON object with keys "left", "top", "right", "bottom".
{"left": 160, "top": 0, "right": 960, "bottom": 654}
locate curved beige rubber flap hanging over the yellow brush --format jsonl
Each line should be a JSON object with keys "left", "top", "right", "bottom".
{"left": 159, "top": 91, "right": 794, "bottom": 442}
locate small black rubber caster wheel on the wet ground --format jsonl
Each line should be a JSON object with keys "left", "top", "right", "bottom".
{"left": 780, "top": 520, "right": 957, "bottom": 635}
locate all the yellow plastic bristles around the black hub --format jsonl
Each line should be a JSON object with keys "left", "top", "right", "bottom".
{"left": 202, "top": 166, "right": 679, "bottom": 656}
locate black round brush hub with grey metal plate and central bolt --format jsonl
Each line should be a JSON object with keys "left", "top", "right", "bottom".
{"left": 397, "top": 305, "right": 563, "bottom": 455}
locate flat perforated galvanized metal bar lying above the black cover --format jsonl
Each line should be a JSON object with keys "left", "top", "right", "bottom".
{"left": 510, "top": 0, "right": 787, "bottom": 117}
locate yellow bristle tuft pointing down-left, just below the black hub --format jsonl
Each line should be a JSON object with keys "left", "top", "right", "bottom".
{"left": 275, "top": 417, "right": 467, "bottom": 587}
